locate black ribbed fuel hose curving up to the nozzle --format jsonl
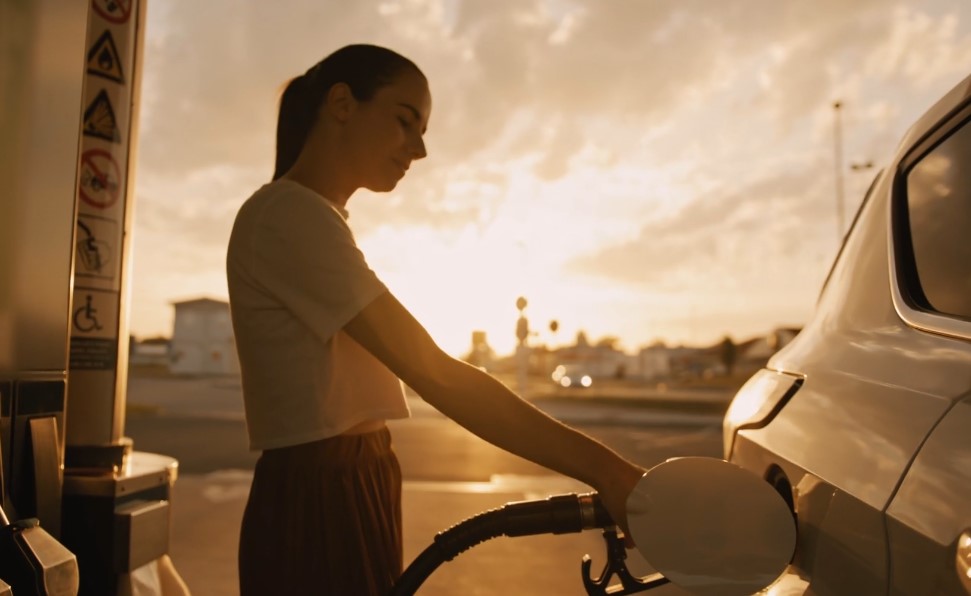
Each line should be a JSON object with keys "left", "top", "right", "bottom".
{"left": 391, "top": 493, "right": 614, "bottom": 596}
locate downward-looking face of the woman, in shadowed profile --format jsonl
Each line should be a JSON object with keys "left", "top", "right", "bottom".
{"left": 345, "top": 69, "right": 432, "bottom": 192}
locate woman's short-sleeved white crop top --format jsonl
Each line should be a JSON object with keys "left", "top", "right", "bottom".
{"left": 226, "top": 179, "right": 410, "bottom": 450}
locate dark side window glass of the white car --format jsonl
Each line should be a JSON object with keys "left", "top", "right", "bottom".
{"left": 907, "top": 122, "right": 971, "bottom": 319}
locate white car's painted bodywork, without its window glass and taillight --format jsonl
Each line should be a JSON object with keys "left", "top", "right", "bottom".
{"left": 726, "top": 72, "right": 971, "bottom": 594}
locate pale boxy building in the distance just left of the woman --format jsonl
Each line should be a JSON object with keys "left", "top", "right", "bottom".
{"left": 169, "top": 298, "right": 239, "bottom": 375}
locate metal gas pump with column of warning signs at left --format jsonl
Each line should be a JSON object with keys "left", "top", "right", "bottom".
{"left": 0, "top": 0, "right": 187, "bottom": 596}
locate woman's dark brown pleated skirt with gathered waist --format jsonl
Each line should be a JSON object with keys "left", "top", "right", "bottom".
{"left": 239, "top": 428, "right": 402, "bottom": 596}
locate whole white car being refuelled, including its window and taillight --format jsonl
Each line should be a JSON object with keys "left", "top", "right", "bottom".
{"left": 723, "top": 77, "right": 971, "bottom": 595}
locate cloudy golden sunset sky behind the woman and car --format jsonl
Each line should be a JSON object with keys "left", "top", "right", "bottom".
{"left": 129, "top": 0, "right": 971, "bottom": 355}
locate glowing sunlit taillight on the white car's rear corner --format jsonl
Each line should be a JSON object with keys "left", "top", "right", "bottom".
{"left": 722, "top": 369, "right": 803, "bottom": 460}
